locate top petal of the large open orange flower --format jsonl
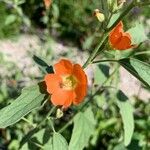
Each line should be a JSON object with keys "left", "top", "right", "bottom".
{"left": 54, "top": 59, "right": 73, "bottom": 75}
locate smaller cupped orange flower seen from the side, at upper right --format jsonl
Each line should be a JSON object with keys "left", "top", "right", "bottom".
{"left": 109, "top": 21, "right": 134, "bottom": 50}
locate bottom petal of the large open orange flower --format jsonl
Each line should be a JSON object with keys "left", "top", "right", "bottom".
{"left": 51, "top": 89, "right": 76, "bottom": 108}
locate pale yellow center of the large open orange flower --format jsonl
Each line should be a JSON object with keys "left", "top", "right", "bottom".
{"left": 61, "top": 75, "right": 77, "bottom": 90}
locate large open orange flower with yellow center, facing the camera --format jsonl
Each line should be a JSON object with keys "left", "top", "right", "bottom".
{"left": 44, "top": 59, "right": 87, "bottom": 108}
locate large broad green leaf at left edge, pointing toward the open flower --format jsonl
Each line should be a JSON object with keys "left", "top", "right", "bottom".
{"left": 0, "top": 82, "right": 46, "bottom": 128}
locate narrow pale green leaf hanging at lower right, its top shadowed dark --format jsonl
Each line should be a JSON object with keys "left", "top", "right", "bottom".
{"left": 117, "top": 91, "right": 134, "bottom": 146}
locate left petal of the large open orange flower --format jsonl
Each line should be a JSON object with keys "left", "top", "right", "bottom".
{"left": 44, "top": 74, "right": 61, "bottom": 94}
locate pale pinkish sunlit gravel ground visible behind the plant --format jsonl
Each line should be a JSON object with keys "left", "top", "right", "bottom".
{"left": 0, "top": 35, "right": 150, "bottom": 102}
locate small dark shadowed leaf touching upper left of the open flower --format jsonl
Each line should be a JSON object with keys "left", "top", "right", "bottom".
{"left": 33, "top": 55, "right": 54, "bottom": 73}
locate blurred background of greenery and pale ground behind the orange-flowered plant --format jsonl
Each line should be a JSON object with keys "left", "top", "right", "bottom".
{"left": 0, "top": 0, "right": 150, "bottom": 150}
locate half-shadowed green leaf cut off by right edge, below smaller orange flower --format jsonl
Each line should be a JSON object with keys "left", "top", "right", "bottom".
{"left": 119, "top": 58, "right": 150, "bottom": 87}
